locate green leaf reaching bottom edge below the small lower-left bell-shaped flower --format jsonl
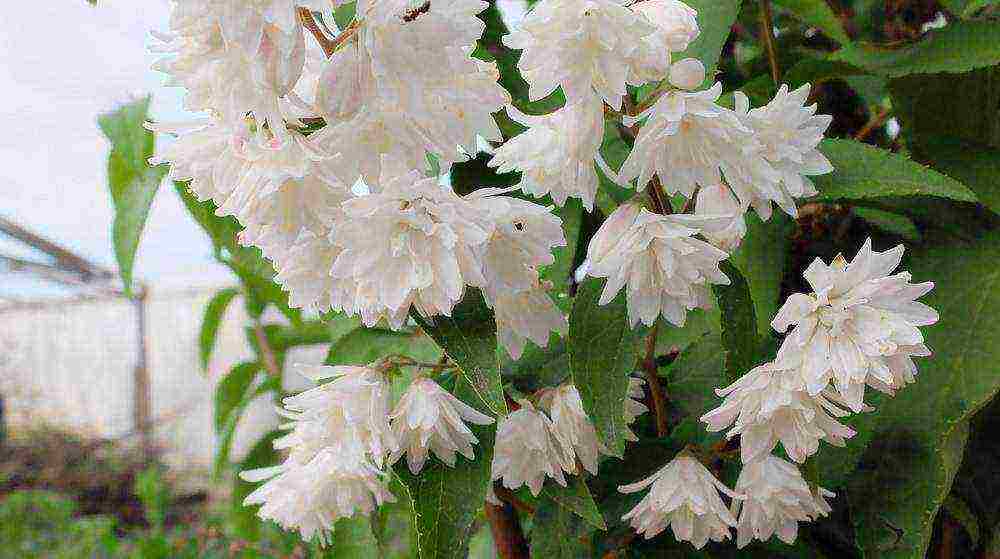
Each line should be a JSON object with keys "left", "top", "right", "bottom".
{"left": 395, "top": 376, "right": 496, "bottom": 559}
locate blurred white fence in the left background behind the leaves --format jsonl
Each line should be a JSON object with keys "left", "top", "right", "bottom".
{"left": 0, "top": 290, "right": 324, "bottom": 486}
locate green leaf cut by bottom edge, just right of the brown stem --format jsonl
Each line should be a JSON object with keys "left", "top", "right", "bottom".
{"left": 531, "top": 492, "right": 597, "bottom": 559}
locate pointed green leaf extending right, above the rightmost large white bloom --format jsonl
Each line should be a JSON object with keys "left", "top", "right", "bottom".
{"left": 812, "top": 139, "right": 976, "bottom": 202}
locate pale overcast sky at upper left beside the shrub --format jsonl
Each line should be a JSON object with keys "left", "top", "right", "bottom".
{"left": 0, "top": 0, "right": 229, "bottom": 296}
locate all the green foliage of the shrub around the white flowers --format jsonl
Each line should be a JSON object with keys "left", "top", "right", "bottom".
{"left": 99, "top": 0, "right": 1000, "bottom": 559}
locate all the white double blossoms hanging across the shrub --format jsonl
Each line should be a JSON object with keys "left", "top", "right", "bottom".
{"left": 143, "top": 0, "right": 900, "bottom": 547}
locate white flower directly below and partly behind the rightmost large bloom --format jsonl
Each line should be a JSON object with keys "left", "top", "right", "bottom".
{"left": 701, "top": 363, "right": 854, "bottom": 464}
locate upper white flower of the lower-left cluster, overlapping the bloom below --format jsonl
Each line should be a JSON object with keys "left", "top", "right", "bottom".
{"left": 284, "top": 363, "right": 398, "bottom": 467}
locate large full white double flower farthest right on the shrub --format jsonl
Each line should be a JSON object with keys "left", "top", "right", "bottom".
{"left": 771, "top": 239, "right": 938, "bottom": 411}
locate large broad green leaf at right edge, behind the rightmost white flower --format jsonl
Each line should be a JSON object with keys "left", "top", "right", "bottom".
{"left": 832, "top": 232, "right": 1000, "bottom": 559}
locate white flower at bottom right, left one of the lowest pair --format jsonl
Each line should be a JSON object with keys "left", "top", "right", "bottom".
{"left": 618, "top": 451, "right": 743, "bottom": 549}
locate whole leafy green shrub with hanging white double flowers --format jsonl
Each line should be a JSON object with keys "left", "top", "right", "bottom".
{"left": 102, "top": 0, "right": 1000, "bottom": 557}
